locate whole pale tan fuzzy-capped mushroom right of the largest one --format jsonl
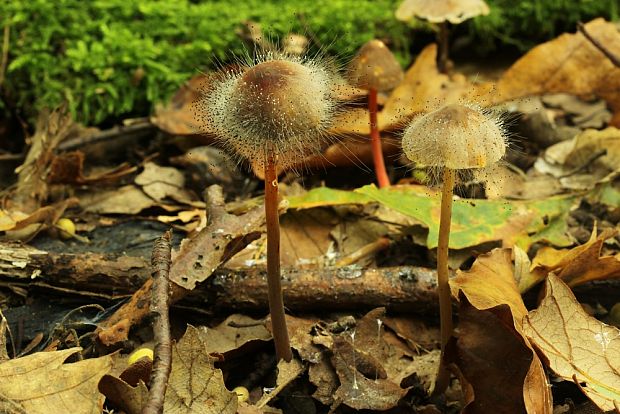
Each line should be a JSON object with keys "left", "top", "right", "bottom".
{"left": 402, "top": 104, "right": 507, "bottom": 393}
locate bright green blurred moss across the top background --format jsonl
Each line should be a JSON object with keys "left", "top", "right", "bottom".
{"left": 0, "top": 0, "right": 619, "bottom": 124}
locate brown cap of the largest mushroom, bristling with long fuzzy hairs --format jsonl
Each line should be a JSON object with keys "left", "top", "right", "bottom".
{"left": 197, "top": 54, "right": 335, "bottom": 168}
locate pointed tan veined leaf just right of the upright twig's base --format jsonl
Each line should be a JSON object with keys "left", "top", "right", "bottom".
{"left": 164, "top": 325, "right": 238, "bottom": 414}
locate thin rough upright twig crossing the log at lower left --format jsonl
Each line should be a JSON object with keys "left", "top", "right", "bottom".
{"left": 142, "top": 230, "right": 172, "bottom": 414}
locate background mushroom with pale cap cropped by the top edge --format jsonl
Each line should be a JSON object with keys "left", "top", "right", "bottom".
{"left": 396, "top": 0, "right": 489, "bottom": 73}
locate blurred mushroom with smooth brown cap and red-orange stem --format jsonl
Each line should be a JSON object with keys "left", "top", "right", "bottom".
{"left": 348, "top": 40, "right": 404, "bottom": 188}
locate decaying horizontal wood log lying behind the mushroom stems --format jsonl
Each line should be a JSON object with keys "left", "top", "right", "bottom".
{"left": 0, "top": 239, "right": 436, "bottom": 313}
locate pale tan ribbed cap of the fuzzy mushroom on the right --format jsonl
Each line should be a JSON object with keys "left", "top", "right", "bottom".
{"left": 402, "top": 104, "right": 507, "bottom": 170}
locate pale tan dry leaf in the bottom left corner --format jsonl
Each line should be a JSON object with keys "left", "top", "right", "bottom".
{"left": 0, "top": 348, "right": 112, "bottom": 414}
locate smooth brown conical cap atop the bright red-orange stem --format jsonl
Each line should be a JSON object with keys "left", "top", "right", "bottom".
{"left": 348, "top": 39, "right": 403, "bottom": 92}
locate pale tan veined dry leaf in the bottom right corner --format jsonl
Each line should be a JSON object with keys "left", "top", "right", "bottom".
{"left": 524, "top": 273, "right": 620, "bottom": 411}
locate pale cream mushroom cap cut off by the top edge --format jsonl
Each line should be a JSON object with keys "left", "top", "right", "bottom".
{"left": 396, "top": 0, "right": 489, "bottom": 24}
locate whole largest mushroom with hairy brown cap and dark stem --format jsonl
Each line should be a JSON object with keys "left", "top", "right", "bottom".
{"left": 197, "top": 52, "right": 335, "bottom": 361}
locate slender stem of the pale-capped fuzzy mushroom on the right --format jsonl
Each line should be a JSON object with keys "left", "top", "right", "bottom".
{"left": 433, "top": 167, "right": 455, "bottom": 394}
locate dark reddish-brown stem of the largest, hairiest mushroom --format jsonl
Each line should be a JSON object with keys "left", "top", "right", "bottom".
{"left": 265, "top": 153, "right": 293, "bottom": 362}
